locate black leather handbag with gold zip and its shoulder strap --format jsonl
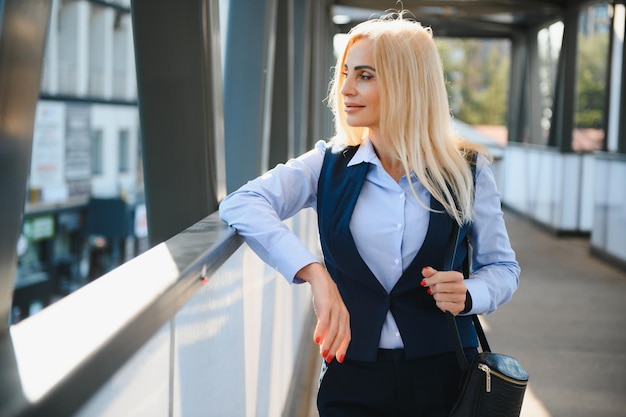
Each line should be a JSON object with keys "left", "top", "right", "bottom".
{"left": 446, "top": 224, "right": 528, "bottom": 417}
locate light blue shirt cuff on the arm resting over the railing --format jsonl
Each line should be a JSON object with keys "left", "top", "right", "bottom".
{"left": 269, "top": 233, "right": 319, "bottom": 284}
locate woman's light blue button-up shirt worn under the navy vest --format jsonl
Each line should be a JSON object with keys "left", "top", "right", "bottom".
{"left": 219, "top": 140, "right": 520, "bottom": 349}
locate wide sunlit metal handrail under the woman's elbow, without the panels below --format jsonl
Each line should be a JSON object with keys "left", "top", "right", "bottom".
{"left": 0, "top": 212, "right": 243, "bottom": 416}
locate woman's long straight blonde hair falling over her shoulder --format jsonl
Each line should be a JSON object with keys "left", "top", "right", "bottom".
{"left": 328, "top": 12, "right": 488, "bottom": 224}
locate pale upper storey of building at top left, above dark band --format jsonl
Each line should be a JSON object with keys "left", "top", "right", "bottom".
{"left": 41, "top": 0, "right": 137, "bottom": 101}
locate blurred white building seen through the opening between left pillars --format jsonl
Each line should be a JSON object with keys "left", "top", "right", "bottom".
{"left": 12, "top": 0, "right": 147, "bottom": 322}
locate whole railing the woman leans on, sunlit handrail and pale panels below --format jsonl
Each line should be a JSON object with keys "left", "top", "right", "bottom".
{"left": 0, "top": 212, "right": 317, "bottom": 416}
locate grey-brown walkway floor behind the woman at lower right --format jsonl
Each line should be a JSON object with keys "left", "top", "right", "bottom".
{"left": 309, "top": 212, "right": 626, "bottom": 417}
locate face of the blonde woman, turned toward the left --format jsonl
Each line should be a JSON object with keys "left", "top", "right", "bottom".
{"left": 341, "top": 39, "right": 380, "bottom": 135}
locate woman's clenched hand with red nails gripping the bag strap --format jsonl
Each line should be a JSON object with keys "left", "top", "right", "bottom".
{"left": 422, "top": 266, "right": 467, "bottom": 316}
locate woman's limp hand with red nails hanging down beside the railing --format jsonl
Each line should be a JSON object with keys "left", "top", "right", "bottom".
{"left": 297, "top": 263, "right": 350, "bottom": 362}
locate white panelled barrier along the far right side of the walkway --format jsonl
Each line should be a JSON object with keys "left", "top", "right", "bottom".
{"left": 499, "top": 144, "right": 626, "bottom": 264}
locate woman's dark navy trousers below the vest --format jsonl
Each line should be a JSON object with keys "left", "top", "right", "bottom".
{"left": 317, "top": 349, "right": 477, "bottom": 417}
